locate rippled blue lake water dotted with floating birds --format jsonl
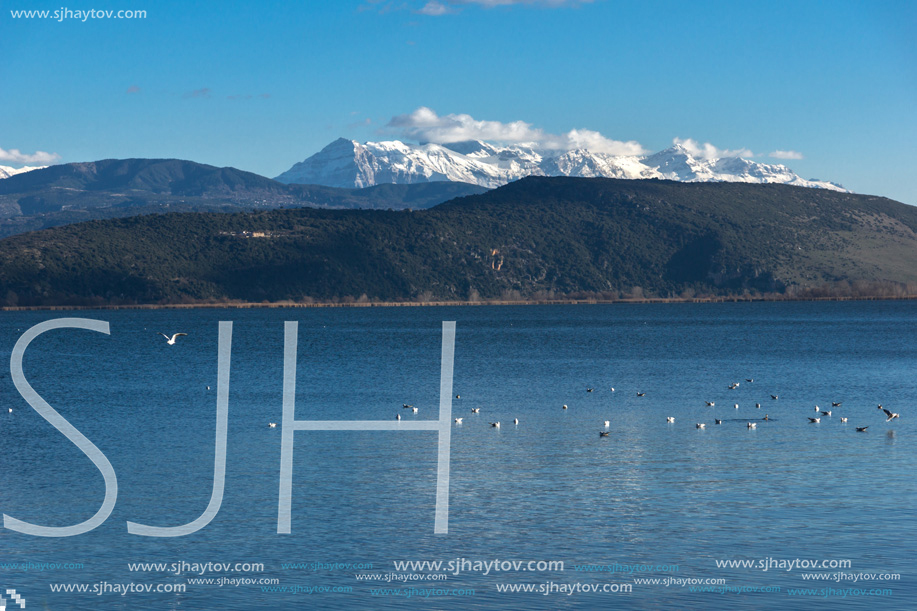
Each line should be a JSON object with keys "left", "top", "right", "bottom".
{"left": 0, "top": 302, "right": 917, "bottom": 610}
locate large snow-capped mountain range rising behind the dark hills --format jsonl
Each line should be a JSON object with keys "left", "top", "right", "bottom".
{"left": 276, "top": 138, "right": 846, "bottom": 191}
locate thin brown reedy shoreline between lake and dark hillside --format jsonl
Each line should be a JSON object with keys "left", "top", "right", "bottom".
{"left": 0, "top": 295, "right": 917, "bottom": 312}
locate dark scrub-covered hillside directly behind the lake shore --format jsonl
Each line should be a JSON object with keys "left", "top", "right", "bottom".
{"left": 0, "top": 177, "right": 917, "bottom": 305}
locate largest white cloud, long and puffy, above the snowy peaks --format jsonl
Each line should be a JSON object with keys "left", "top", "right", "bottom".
{"left": 387, "top": 106, "right": 646, "bottom": 155}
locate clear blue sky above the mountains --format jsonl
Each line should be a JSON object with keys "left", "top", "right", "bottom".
{"left": 0, "top": 0, "right": 917, "bottom": 204}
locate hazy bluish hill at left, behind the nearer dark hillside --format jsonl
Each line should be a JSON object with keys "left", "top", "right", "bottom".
{"left": 0, "top": 159, "right": 486, "bottom": 238}
